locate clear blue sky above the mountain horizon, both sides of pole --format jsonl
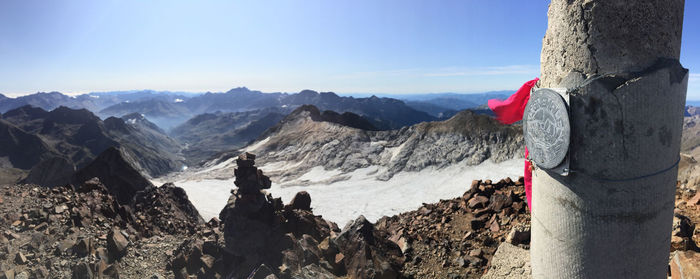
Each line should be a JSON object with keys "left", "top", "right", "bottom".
{"left": 0, "top": 0, "right": 700, "bottom": 100}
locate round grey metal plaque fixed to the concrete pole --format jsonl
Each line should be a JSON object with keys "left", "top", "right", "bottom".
{"left": 523, "top": 88, "right": 571, "bottom": 169}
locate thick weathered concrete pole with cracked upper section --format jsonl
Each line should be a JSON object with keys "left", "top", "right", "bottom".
{"left": 531, "top": 0, "right": 688, "bottom": 278}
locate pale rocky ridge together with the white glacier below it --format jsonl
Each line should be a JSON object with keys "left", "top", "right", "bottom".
{"left": 161, "top": 106, "right": 523, "bottom": 224}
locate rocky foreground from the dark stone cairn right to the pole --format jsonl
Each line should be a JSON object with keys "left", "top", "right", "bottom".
{"left": 169, "top": 154, "right": 529, "bottom": 278}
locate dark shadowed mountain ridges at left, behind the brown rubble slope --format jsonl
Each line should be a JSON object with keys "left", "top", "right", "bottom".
{"left": 0, "top": 105, "right": 184, "bottom": 186}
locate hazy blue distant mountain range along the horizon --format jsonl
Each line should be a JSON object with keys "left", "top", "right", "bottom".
{"left": 0, "top": 87, "right": 507, "bottom": 131}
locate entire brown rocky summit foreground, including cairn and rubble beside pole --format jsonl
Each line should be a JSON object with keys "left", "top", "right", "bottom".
{"left": 0, "top": 153, "right": 700, "bottom": 279}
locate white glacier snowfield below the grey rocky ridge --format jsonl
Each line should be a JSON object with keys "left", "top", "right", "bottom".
{"left": 175, "top": 159, "right": 523, "bottom": 227}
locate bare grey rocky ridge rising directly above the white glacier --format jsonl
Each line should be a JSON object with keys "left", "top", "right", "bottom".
{"left": 208, "top": 106, "right": 523, "bottom": 183}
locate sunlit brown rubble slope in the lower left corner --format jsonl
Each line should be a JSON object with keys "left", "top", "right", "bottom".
{"left": 0, "top": 179, "right": 203, "bottom": 278}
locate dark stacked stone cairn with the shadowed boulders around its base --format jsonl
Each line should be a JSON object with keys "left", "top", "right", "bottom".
{"left": 170, "top": 153, "right": 402, "bottom": 278}
